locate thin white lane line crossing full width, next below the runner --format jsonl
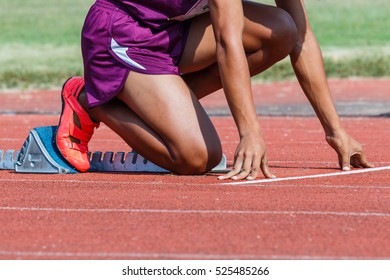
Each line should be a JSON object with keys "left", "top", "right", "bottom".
{"left": 0, "top": 206, "right": 390, "bottom": 217}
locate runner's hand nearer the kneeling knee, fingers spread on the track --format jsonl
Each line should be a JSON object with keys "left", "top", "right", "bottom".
{"left": 219, "top": 134, "right": 275, "bottom": 180}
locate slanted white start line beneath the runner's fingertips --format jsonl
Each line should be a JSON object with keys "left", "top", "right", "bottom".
{"left": 222, "top": 166, "right": 390, "bottom": 186}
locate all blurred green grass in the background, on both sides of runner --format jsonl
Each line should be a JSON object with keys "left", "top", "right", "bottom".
{"left": 0, "top": 0, "right": 390, "bottom": 89}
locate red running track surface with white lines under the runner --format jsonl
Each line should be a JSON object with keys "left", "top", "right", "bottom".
{"left": 0, "top": 78, "right": 390, "bottom": 259}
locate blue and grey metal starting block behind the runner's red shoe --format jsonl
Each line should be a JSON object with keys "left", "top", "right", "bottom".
{"left": 0, "top": 126, "right": 228, "bottom": 174}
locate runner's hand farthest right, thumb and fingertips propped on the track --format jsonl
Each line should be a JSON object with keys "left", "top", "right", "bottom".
{"left": 326, "top": 129, "right": 374, "bottom": 171}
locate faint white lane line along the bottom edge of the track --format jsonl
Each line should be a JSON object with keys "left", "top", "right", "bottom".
{"left": 0, "top": 251, "right": 388, "bottom": 260}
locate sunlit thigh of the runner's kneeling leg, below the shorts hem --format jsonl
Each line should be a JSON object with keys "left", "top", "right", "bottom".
{"left": 118, "top": 72, "right": 219, "bottom": 148}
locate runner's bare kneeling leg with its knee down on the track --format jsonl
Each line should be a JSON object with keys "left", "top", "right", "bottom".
{"left": 91, "top": 72, "right": 222, "bottom": 174}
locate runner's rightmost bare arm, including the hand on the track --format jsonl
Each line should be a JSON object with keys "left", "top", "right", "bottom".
{"left": 275, "top": 0, "right": 372, "bottom": 170}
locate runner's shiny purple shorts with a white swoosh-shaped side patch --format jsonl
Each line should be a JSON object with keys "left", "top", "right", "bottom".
{"left": 81, "top": 0, "right": 190, "bottom": 107}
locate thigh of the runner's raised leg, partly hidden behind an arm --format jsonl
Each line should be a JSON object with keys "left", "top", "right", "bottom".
{"left": 179, "top": 1, "right": 286, "bottom": 73}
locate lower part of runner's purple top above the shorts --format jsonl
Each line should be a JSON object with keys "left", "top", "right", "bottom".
{"left": 114, "top": 0, "right": 208, "bottom": 29}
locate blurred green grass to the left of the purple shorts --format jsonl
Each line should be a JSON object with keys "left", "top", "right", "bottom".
{"left": 0, "top": 0, "right": 93, "bottom": 89}
